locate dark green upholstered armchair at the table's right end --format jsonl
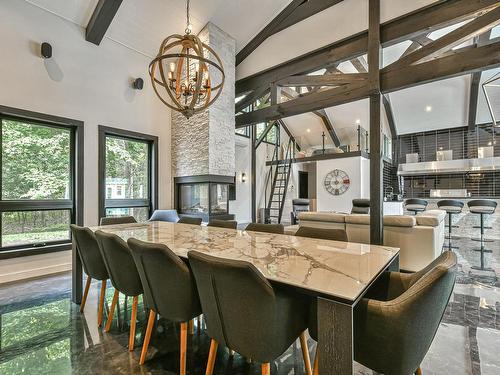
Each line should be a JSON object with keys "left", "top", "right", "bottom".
{"left": 309, "top": 251, "right": 457, "bottom": 375}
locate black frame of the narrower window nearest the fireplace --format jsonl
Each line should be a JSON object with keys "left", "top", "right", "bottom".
{"left": 98, "top": 125, "right": 158, "bottom": 222}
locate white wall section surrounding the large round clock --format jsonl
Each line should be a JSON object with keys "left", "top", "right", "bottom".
{"left": 316, "top": 157, "right": 370, "bottom": 212}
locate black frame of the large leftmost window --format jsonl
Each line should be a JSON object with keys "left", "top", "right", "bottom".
{"left": 0, "top": 105, "right": 84, "bottom": 259}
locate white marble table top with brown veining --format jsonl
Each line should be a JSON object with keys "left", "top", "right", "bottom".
{"left": 91, "top": 221, "right": 399, "bottom": 301}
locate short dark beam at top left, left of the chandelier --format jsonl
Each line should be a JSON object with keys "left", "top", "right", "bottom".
{"left": 85, "top": 0, "right": 122, "bottom": 45}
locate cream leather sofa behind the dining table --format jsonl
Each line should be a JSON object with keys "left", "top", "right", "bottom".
{"left": 298, "top": 210, "right": 446, "bottom": 272}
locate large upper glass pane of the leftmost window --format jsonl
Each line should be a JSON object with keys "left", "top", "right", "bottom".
{"left": 2, "top": 120, "right": 71, "bottom": 200}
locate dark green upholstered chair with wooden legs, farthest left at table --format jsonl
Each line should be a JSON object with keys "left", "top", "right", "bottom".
{"left": 70, "top": 224, "right": 109, "bottom": 326}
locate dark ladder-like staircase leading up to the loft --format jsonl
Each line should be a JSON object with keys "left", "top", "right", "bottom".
{"left": 266, "top": 139, "right": 295, "bottom": 223}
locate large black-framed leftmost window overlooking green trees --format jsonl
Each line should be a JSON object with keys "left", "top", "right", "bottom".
{"left": 0, "top": 107, "right": 83, "bottom": 257}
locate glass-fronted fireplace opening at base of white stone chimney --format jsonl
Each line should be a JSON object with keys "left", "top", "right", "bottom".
{"left": 175, "top": 175, "right": 234, "bottom": 221}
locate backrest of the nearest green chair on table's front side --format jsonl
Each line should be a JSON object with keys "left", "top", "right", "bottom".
{"left": 188, "top": 251, "right": 276, "bottom": 355}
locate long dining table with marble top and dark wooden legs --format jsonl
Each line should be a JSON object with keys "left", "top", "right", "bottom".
{"left": 72, "top": 221, "right": 399, "bottom": 375}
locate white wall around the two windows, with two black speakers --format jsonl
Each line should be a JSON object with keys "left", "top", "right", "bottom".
{"left": 0, "top": 0, "right": 172, "bottom": 225}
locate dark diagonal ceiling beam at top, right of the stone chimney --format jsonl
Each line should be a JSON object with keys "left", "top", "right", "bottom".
{"left": 236, "top": 0, "right": 342, "bottom": 66}
